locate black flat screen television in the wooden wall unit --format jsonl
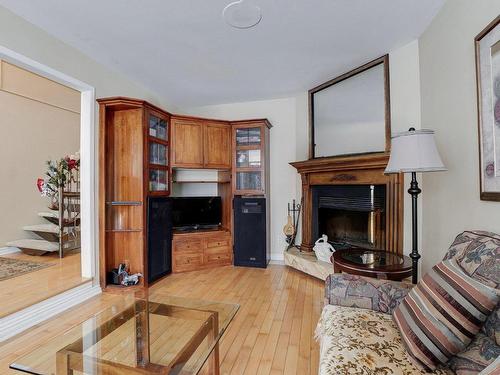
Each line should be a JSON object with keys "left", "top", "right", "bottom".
{"left": 172, "top": 197, "right": 222, "bottom": 230}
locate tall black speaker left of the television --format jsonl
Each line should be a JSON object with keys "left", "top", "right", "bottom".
{"left": 148, "top": 197, "right": 172, "bottom": 283}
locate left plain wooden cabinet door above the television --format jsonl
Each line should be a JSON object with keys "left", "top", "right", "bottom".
{"left": 171, "top": 118, "right": 203, "bottom": 168}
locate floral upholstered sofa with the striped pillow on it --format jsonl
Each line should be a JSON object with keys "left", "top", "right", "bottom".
{"left": 317, "top": 231, "right": 500, "bottom": 375}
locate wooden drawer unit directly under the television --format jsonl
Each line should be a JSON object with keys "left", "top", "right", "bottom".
{"left": 172, "top": 230, "right": 233, "bottom": 273}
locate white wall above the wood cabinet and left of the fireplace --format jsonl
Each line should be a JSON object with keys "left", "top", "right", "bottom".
{"left": 183, "top": 98, "right": 297, "bottom": 260}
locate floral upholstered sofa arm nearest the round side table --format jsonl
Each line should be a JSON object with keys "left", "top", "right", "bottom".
{"left": 325, "top": 273, "right": 413, "bottom": 314}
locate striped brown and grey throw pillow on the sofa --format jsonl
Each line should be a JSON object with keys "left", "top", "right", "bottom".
{"left": 393, "top": 259, "right": 499, "bottom": 370}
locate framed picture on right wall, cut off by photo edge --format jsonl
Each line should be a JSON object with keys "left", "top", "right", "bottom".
{"left": 475, "top": 16, "right": 500, "bottom": 201}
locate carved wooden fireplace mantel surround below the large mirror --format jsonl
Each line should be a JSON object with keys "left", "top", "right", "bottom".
{"left": 290, "top": 152, "right": 404, "bottom": 254}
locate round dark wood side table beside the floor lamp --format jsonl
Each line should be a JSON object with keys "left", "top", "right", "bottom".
{"left": 332, "top": 248, "right": 412, "bottom": 281}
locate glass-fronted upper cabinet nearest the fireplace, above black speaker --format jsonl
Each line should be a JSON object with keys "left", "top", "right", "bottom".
{"left": 231, "top": 119, "right": 271, "bottom": 195}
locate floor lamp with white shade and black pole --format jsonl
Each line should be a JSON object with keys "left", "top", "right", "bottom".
{"left": 385, "top": 128, "right": 446, "bottom": 284}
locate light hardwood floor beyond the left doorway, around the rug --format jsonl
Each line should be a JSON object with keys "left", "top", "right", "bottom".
{"left": 0, "top": 251, "right": 89, "bottom": 318}
